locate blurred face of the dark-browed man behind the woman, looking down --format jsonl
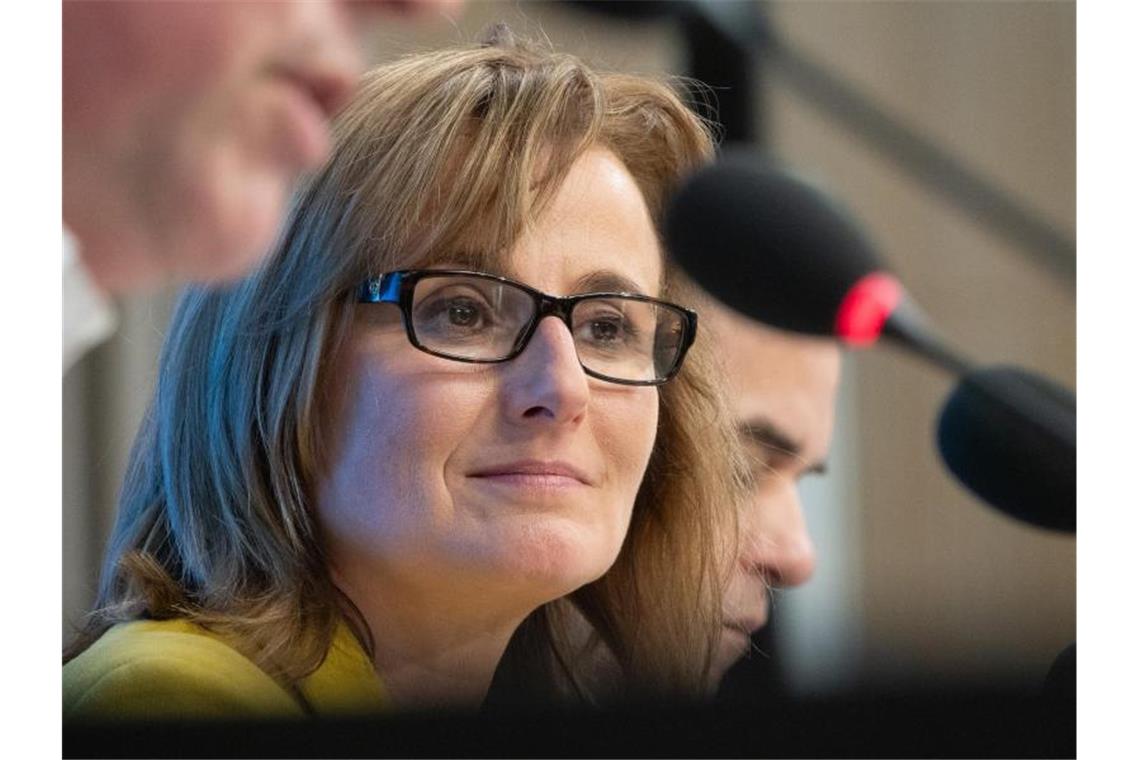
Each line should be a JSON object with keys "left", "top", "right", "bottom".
{"left": 701, "top": 310, "right": 839, "bottom": 683}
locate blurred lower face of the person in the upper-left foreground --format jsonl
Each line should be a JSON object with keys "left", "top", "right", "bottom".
{"left": 63, "top": 0, "right": 456, "bottom": 292}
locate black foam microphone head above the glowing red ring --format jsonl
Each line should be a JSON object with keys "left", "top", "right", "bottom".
{"left": 665, "top": 152, "right": 881, "bottom": 335}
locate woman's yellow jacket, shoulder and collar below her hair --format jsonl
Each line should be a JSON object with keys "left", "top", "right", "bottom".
{"left": 64, "top": 620, "right": 388, "bottom": 720}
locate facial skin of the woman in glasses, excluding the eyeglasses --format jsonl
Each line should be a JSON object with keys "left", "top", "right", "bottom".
{"left": 317, "top": 149, "right": 661, "bottom": 604}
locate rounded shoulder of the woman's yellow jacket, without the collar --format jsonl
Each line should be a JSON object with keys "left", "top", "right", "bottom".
{"left": 64, "top": 620, "right": 301, "bottom": 719}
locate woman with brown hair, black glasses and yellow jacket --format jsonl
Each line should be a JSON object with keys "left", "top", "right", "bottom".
{"left": 64, "top": 30, "right": 741, "bottom": 717}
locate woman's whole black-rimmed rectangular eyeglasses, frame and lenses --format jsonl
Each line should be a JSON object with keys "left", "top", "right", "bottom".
{"left": 359, "top": 269, "right": 697, "bottom": 385}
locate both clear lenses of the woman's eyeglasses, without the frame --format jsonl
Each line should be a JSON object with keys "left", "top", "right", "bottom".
{"left": 412, "top": 275, "right": 684, "bottom": 382}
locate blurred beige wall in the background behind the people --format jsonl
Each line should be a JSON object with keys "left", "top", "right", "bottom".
{"left": 63, "top": 1, "right": 1076, "bottom": 690}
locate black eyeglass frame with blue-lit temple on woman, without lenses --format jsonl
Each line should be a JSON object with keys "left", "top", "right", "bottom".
{"left": 357, "top": 269, "right": 697, "bottom": 385}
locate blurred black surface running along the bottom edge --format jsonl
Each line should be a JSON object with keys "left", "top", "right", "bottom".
{"left": 63, "top": 693, "right": 1076, "bottom": 758}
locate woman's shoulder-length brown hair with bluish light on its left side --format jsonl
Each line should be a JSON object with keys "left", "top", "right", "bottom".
{"left": 71, "top": 30, "right": 742, "bottom": 693}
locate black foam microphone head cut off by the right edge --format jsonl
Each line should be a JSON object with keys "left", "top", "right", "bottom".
{"left": 938, "top": 367, "right": 1076, "bottom": 532}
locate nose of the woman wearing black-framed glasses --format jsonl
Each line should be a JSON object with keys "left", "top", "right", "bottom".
{"left": 504, "top": 317, "right": 589, "bottom": 422}
